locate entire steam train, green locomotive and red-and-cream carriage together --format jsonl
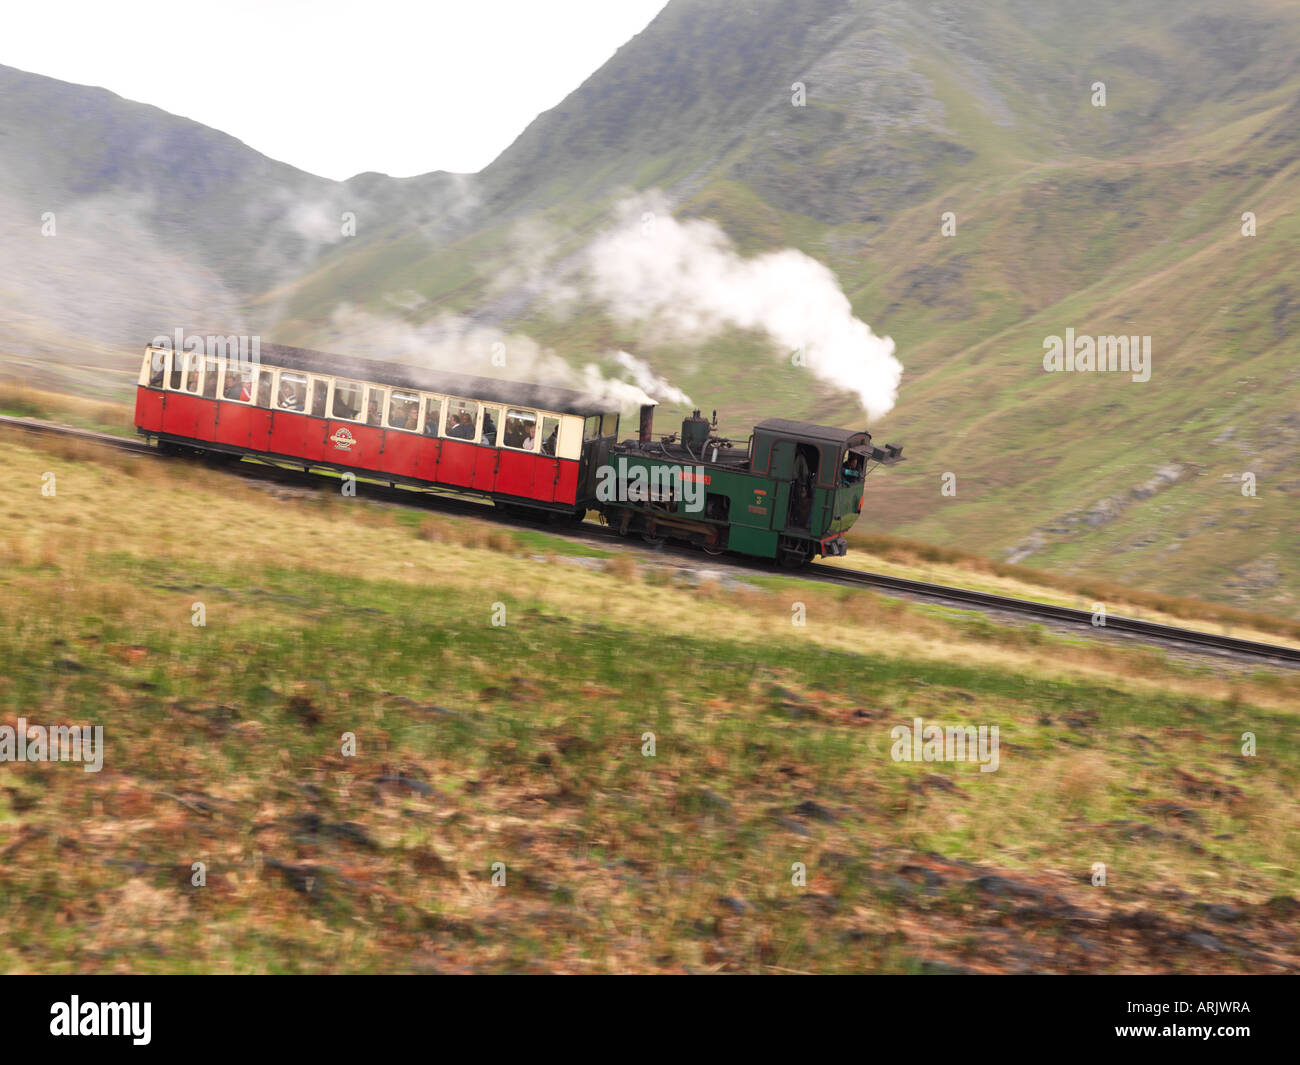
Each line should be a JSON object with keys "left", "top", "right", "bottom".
{"left": 135, "top": 337, "right": 902, "bottom": 566}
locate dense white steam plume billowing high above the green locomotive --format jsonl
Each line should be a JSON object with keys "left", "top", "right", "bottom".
{"left": 588, "top": 195, "right": 902, "bottom": 419}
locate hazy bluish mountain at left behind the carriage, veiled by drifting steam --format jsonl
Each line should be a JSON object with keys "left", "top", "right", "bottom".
{"left": 0, "top": 66, "right": 455, "bottom": 368}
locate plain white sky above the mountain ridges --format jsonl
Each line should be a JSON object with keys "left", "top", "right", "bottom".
{"left": 10, "top": 0, "right": 667, "bottom": 178}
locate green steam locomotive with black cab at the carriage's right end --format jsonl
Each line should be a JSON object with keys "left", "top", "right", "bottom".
{"left": 595, "top": 407, "right": 902, "bottom": 567}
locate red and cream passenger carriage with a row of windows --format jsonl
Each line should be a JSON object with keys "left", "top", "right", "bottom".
{"left": 135, "top": 338, "right": 619, "bottom": 516}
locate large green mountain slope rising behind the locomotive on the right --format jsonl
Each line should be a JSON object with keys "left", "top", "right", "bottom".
{"left": 266, "top": 0, "right": 1300, "bottom": 612}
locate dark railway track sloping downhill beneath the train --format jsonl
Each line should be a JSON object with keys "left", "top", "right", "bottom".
{"left": 0, "top": 415, "right": 1300, "bottom": 667}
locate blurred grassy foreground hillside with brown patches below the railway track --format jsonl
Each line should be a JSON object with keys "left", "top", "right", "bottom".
{"left": 0, "top": 436, "right": 1300, "bottom": 971}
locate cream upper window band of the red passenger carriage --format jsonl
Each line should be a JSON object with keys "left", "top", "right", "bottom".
{"left": 139, "top": 347, "right": 584, "bottom": 459}
